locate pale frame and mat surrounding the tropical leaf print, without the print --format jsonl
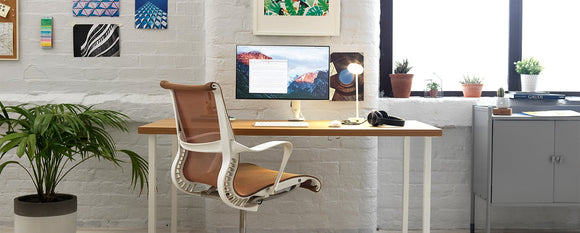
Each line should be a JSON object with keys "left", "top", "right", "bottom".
{"left": 253, "top": 0, "right": 340, "bottom": 36}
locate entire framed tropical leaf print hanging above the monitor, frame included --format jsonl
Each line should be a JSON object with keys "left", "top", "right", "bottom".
{"left": 253, "top": 0, "right": 340, "bottom": 36}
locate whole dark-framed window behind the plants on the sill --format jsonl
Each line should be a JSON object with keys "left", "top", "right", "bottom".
{"left": 380, "top": 0, "right": 580, "bottom": 97}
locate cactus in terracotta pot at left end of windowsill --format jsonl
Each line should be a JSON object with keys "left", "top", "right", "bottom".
{"left": 389, "top": 59, "right": 414, "bottom": 98}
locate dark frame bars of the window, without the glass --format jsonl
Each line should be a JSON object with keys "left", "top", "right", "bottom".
{"left": 379, "top": 0, "right": 580, "bottom": 97}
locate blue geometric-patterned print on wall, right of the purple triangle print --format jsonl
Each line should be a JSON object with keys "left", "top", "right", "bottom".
{"left": 135, "top": 0, "right": 167, "bottom": 29}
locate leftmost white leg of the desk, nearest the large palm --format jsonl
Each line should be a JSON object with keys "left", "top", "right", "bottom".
{"left": 148, "top": 134, "right": 157, "bottom": 233}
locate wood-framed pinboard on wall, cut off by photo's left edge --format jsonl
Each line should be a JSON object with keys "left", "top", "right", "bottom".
{"left": 0, "top": 0, "right": 18, "bottom": 60}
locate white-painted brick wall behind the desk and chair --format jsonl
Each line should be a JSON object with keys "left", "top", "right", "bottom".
{"left": 0, "top": 0, "right": 578, "bottom": 230}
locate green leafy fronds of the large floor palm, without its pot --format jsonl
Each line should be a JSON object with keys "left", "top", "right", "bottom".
{"left": 0, "top": 102, "right": 148, "bottom": 201}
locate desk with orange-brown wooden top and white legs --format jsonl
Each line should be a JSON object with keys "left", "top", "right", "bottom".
{"left": 138, "top": 119, "right": 443, "bottom": 233}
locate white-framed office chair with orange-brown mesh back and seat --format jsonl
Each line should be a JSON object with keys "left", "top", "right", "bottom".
{"left": 160, "top": 81, "right": 321, "bottom": 233}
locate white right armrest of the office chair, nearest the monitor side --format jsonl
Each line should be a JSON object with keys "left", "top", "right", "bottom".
{"left": 232, "top": 141, "right": 292, "bottom": 194}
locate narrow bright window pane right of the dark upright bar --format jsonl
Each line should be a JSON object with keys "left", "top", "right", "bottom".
{"left": 522, "top": 0, "right": 580, "bottom": 91}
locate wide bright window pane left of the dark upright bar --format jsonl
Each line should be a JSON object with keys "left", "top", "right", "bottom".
{"left": 393, "top": 0, "right": 509, "bottom": 91}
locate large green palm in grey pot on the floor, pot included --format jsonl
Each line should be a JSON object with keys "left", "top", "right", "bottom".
{"left": 0, "top": 102, "right": 148, "bottom": 233}
